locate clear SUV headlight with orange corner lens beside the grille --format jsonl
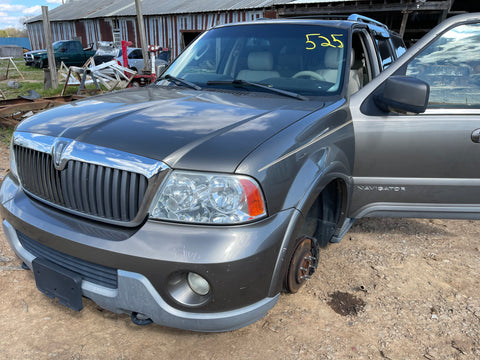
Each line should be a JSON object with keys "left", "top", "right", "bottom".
{"left": 150, "top": 171, "right": 266, "bottom": 224}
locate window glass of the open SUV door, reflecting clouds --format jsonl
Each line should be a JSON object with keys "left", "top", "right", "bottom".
{"left": 406, "top": 24, "right": 480, "bottom": 107}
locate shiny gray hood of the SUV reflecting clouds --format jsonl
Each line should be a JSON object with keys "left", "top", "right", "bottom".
{"left": 17, "top": 86, "right": 324, "bottom": 172}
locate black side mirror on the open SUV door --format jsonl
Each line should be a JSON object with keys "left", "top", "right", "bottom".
{"left": 375, "top": 76, "right": 430, "bottom": 114}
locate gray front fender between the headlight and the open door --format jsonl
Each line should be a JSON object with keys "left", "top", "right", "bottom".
{"left": 236, "top": 102, "right": 355, "bottom": 295}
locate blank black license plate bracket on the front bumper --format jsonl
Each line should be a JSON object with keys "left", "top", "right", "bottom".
{"left": 32, "top": 258, "right": 83, "bottom": 311}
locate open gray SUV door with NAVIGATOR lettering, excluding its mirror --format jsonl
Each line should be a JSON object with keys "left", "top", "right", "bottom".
{"left": 349, "top": 15, "right": 480, "bottom": 218}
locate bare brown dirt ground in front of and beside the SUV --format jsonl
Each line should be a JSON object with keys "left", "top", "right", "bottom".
{"left": 0, "top": 142, "right": 480, "bottom": 360}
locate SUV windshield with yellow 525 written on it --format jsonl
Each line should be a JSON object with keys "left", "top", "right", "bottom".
{"left": 159, "top": 23, "right": 348, "bottom": 96}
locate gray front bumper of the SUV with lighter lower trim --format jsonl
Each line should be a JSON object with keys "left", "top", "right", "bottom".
{"left": 0, "top": 175, "right": 295, "bottom": 331}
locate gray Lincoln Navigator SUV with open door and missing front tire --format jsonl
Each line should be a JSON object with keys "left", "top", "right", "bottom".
{"left": 0, "top": 14, "right": 480, "bottom": 331}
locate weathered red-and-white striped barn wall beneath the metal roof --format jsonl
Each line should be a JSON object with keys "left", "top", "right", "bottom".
{"left": 27, "top": 10, "right": 266, "bottom": 53}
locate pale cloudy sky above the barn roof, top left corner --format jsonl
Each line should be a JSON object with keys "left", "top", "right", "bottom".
{"left": 0, "top": 0, "right": 62, "bottom": 29}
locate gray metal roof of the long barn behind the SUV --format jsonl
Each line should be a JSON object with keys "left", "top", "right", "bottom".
{"left": 26, "top": 0, "right": 300, "bottom": 23}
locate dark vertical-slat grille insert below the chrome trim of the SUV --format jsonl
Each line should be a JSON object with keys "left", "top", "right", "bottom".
{"left": 14, "top": 145, "right": 148, "bottom": 222}
